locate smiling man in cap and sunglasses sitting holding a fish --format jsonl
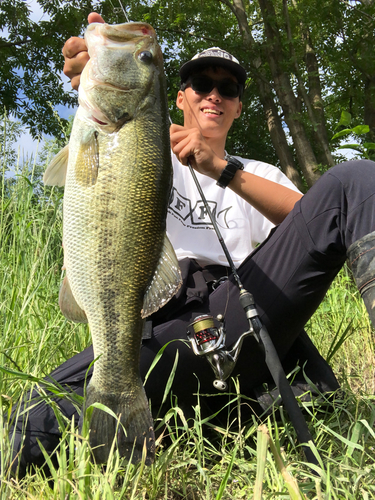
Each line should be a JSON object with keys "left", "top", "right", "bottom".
{"left": 8, "top": 14, "right": 375, "bottom": 475}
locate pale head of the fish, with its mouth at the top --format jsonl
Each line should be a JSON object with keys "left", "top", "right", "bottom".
{"left": 79, "top": 23, "right": 162, "bottom": 130}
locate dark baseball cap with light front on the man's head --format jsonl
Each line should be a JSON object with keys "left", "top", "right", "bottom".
{"left": 180, "top": 47, "right": 246, "bottom": 85}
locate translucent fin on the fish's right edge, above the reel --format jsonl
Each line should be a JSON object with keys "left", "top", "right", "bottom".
{"left": 142, "top": 235, "right": 182, "bottom": 318}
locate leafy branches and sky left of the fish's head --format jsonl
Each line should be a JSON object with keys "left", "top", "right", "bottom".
{"left": 0, "top": 0, "right": 97, "bottom": 137}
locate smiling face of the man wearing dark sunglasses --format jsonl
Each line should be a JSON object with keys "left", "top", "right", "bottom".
{"left": 176, "top": 67, "right": 242, "bottom": 138}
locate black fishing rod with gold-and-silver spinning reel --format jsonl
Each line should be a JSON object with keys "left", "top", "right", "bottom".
{"left": 184, "top": 155, "right": 318, "bottom": 465}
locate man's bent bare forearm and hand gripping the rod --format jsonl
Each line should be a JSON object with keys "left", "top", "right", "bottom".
{"left": 170, "top": 125, "right": 302, "bottom": 224}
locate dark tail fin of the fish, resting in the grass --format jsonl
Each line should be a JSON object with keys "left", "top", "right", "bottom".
{"left": 79, "top": 381, "right": 155, "bottom": 465}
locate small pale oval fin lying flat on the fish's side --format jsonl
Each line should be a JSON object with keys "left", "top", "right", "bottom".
{"left": 75, "top": 130, "right": 99, "bottom": 187}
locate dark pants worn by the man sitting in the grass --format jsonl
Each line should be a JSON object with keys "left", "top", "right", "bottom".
{"left": 8, "top": 161, "right": 375, "bottom": 475}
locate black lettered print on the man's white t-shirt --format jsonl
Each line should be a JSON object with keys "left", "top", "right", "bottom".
{"left": 168, "top": 187, "right": 232, "bottom": 229}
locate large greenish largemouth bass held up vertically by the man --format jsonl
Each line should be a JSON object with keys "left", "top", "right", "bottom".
{"left": 44, "top": 23, "right": 181, "bottom": 464}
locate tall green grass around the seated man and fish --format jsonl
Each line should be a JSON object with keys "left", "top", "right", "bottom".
{"left": 0, "top": 143, "right": 375, "bottom": 500}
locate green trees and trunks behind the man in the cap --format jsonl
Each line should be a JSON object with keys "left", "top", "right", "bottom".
{"left": 103, "top": 0, "right": 375, "bottom": 189}
